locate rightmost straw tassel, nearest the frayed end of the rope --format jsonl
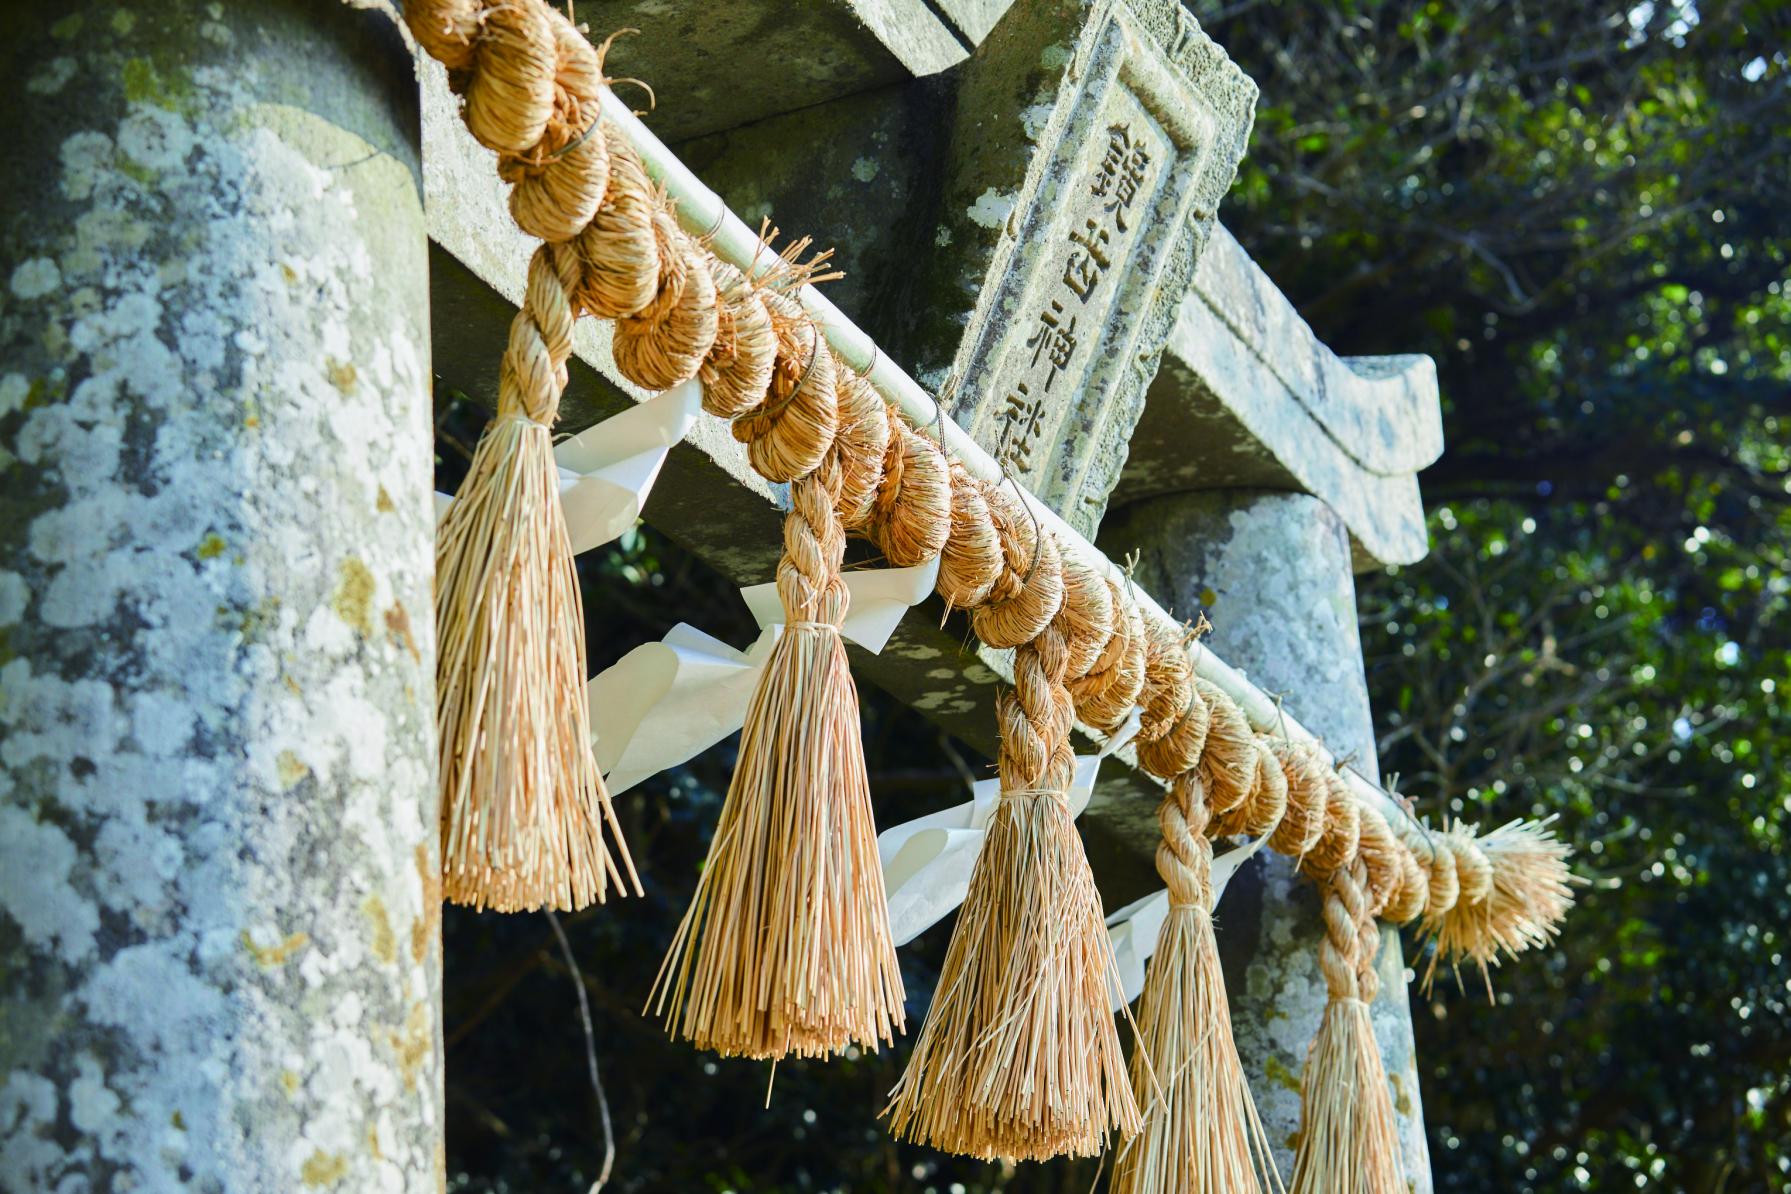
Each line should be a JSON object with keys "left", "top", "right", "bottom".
{"left": 1291, "top": 857, "right": 1404, "bottom": 1194}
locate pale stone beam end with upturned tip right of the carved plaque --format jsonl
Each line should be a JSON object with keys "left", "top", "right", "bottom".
{"left": 1114, "top": 227, "right": 1442, "bottom": 571}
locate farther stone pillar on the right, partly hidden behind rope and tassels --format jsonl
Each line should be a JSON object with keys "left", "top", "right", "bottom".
{"left": 1101, "top": 490, "right": 1431, "bottom": 1194}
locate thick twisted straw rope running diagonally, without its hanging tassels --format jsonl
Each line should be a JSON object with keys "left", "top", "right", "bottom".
{"left": 405, "top": 0, "right": 1565, "bottom": 943}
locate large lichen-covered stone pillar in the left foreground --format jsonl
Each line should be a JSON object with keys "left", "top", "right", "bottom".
{"left": 0, "top": 0, "right": 444, "bottom": 1192}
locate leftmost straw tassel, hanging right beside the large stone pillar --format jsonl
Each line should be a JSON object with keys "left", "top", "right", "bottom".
{"left": 435, "top": 245, "right": 639, "bottom": 911}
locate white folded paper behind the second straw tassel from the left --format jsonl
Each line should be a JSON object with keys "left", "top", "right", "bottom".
{"left": 586, "top": 559, "right": 938, "bottom": 795}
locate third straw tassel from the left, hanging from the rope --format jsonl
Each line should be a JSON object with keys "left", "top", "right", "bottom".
{"left": 885, "top": 551, "right": 1139, "bottom": 1160}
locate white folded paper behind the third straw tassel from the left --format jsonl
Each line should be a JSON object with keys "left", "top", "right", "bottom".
{"left": 878, "top": 709, "right": 1139, "bottom": 945}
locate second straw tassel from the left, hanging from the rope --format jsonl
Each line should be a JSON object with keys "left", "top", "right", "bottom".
{"left": 650, "top": 328, "right": 904, "bottom": 1058}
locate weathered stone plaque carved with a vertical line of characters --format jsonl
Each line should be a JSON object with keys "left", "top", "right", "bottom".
{"left": 921, "top": 0, "right": 1255, "bottom": 537}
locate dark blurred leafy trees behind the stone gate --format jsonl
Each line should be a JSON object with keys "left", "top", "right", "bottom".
{"left": 442, "top": 0, "right": 1791, "bottom": 1194}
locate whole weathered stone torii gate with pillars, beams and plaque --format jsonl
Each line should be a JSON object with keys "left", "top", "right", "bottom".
{"left": 0, "top": 0, "right": 1440, "bottom": 1190}
